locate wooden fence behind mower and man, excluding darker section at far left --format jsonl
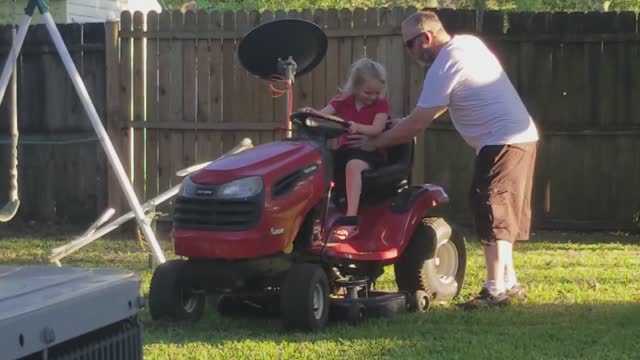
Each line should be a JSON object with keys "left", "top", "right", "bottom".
{"left": 109, "top": 8, "right": 640, "bottom": 229}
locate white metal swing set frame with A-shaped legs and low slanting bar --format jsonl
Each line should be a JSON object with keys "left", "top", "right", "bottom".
{"left": 0, "top": 0, "right": 253, "bottom": 266}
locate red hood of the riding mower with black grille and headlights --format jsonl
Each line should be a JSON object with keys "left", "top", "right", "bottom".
{"left": 173, "top": 141, "right": 330, "bottom": 259}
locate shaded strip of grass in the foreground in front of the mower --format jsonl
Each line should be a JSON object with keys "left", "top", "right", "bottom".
{"left": 144, "top": 303, "right": 640, "bottom": 359}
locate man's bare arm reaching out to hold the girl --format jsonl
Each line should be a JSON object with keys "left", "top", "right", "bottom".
{"left": 369, "top": 105, "right": 447, "bottom": 148}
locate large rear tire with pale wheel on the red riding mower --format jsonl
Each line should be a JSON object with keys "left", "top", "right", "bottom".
{"left": 394, "top": 217, "right": 467, "bottom": 303}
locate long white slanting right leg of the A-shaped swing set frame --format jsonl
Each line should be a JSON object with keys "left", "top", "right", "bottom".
{"left": 40, "top": 11, "right": 166, "bottom": 264}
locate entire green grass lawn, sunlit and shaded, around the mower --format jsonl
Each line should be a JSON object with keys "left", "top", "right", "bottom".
{"left": 0, "top": 229, "right": 640, "bottom": 359}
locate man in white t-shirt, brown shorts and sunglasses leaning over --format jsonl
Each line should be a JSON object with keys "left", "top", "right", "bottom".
{"left": 351, "top": 11, "right": 538, "bottom": 309}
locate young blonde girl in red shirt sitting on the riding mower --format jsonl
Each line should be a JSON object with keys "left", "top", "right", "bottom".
{"left": 303, "top": 58, "right": 389, "bottom": 240}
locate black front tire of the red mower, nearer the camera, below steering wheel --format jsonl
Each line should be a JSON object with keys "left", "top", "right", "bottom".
{"left": 280, "top": 264, "right": 330, "bottom": 331}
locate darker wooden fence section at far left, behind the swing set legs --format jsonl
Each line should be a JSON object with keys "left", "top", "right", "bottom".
{"left": 0, "top": 24, "right": 107, "bottom": 224}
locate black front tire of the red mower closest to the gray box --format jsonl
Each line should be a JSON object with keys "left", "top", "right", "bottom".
{"left": 149, "top": 260, "right": 206, "bottom": 321}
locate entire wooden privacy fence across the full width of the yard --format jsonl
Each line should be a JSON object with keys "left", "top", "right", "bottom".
{"left": 0, "top": 8, "right": 640, "bottom": 230}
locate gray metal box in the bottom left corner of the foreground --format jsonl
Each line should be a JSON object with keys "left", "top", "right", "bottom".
{"left": 0, "top": 266, "right": 143, "bottom": 360}
